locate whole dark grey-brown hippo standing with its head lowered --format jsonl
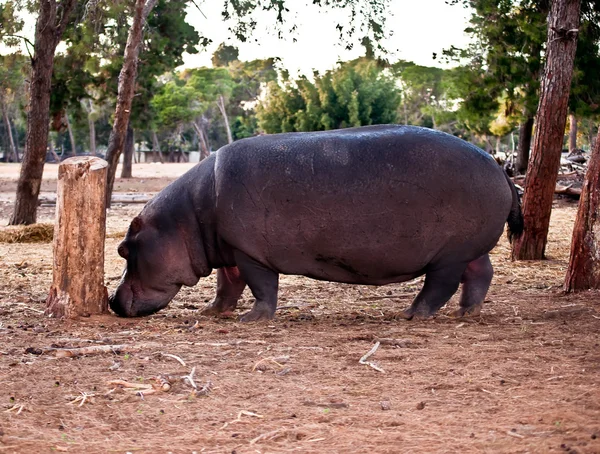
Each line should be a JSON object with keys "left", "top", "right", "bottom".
{"left": 109, "top": 125, "right": 523, "bottom": 322}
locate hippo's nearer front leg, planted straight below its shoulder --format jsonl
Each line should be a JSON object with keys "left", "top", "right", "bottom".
{"left": 234, "top": 250, "right": 279, "bottom": 322}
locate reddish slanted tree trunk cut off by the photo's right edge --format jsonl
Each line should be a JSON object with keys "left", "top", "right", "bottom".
{"left": 565, "top": 130, "right": 600, "bottom": 292}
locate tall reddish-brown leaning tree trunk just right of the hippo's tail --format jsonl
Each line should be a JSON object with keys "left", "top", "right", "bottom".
{"left": 512, "top": 0, "right": 581, "bottom": 260}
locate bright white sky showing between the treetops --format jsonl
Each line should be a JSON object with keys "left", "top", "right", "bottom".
{"left": 5, "top": 0, "right": 471, "bottom": 76}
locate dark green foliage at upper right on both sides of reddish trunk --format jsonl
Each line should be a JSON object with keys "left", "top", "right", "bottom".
{"left": 444, "top": 0, "right": 600, "bottom": 138}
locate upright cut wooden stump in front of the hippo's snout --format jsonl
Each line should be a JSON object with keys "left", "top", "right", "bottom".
{"left": 46, "top": 156, "right": 108, "bottom": 318}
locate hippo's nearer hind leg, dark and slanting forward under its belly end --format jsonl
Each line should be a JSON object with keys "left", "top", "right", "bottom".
{"left": 401, "top": 263, "right": 467, "bottom": 320}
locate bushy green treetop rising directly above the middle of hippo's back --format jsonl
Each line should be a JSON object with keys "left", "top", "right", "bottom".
{"left": 257, "top": 58, "right": 399, "bottom": 133}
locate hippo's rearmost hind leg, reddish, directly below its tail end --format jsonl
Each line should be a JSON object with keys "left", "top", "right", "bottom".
{"left": 454, "top": 254, "right": 494, "bottom": 317}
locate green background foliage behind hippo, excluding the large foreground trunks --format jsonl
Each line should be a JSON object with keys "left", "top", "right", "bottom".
{"left": 0, "top": 0, "right": 600, "bottom": 168}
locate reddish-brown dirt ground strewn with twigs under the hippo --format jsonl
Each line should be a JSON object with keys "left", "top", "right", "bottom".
{"left": 0, "top": 165, "right": 600, "bottom": 454}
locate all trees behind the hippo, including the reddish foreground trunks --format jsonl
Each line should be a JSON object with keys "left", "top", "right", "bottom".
{"left": 0, "top": 0, "right": 600, "bottom": 285}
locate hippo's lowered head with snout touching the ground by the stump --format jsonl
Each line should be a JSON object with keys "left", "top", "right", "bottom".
{"left": 109, "top": 213, "right": 204, "bottom": 317}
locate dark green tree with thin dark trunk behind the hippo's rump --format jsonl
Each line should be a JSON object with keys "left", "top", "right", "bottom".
{"left": 444, "top": 0, "right": 549, "bottom": 173}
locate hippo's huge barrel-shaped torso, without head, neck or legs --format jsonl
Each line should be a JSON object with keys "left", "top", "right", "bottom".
{"left": 215, "top": 126, "right": 512, "bottom": 283}
